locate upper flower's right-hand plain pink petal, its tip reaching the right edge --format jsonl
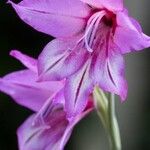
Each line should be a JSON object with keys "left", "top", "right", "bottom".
{"left": 114, "top": 12, "right": 150, "bottom": 54}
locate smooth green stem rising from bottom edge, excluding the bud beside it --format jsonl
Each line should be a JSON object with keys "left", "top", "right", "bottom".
{"left": 108, "top": 94, "right": 121, "bottom": 150}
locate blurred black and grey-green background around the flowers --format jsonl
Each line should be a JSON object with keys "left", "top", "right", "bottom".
{"left": 0, "top": 0, "right": 150, "bottom": 150}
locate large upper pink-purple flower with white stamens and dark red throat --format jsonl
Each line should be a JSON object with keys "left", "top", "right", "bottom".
{"left": 11, "top": 0, "right": 150, "bottom": 117}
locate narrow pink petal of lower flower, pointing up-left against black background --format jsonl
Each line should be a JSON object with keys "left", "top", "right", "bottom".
{"left": 10, "top": 50, "right": 37, "bottom": 73}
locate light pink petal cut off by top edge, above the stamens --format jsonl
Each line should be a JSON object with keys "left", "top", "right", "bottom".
{"left": 81, "top": 0, "right": 123, "bottom": 11}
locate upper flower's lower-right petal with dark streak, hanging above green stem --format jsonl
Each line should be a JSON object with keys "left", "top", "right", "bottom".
{"left": 93, "top": 44, "right": 127, "bottom": 100}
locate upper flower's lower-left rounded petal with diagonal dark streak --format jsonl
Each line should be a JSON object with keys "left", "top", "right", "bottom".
{"left": 38, "top": 37, "right": 88, "bottom": 80}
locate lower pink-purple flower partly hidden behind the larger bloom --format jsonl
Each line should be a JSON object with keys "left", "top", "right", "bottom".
{"left": 0, "top": 51, "right": 93, "bottom": 150}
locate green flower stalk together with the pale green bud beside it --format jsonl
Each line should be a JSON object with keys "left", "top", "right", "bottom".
{"left": 93, "top": 87, "right": 121, "bottom": 150}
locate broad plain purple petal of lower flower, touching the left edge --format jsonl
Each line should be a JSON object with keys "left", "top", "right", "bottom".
{"left": 0, "top": 70, "right": 63, "bottom": 111}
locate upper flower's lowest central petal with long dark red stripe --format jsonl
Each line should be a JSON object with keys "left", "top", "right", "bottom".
{"left": 65, "top": 62, "right": 94, "bottom": 117}
